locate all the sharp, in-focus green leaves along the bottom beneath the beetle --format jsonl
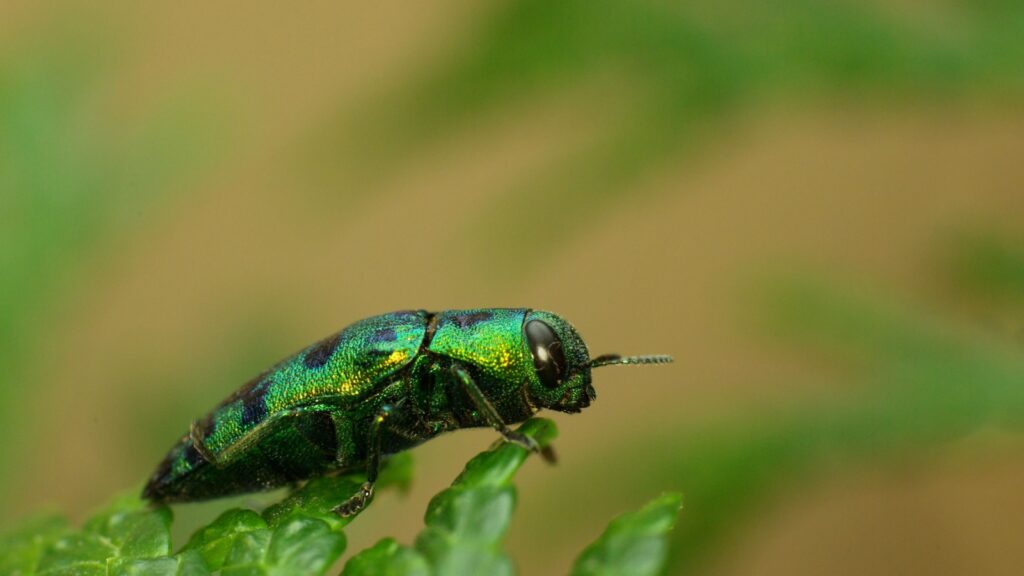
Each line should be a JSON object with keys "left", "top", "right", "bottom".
{"left": 0, "top": 419, "right": 681, "bottom": 576}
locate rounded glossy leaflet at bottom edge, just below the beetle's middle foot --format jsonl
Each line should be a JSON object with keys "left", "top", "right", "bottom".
{"left": 221, "top": 518, "right": 345, "bottom": 576}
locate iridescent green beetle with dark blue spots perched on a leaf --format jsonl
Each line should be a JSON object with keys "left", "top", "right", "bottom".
{"left": 143, "top": 308, "right": 671, "bottom": 516}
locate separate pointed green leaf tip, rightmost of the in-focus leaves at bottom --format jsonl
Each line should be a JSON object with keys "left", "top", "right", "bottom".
{"left": 572, "top": 493, "right": 682, "bottom": 576}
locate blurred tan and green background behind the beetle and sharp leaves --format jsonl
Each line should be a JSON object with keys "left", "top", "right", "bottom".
{"left": 0, "top": 0, "right": 1024, "bottom": 575}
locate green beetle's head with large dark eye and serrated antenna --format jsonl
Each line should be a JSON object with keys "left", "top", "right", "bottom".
{"left": 522, "top": 311, "right": 672, "bottom": 412}
